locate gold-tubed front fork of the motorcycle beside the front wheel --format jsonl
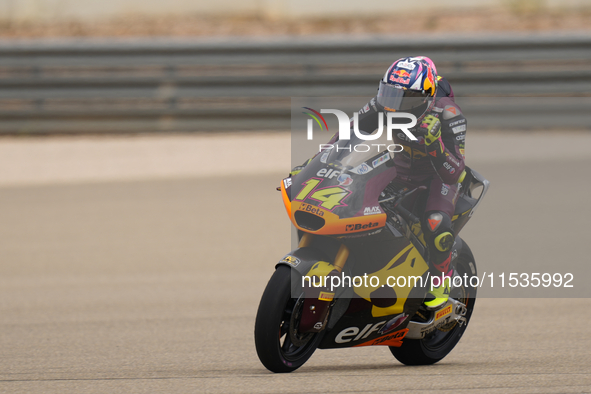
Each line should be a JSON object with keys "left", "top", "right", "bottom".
{"left": 298, "top": 233, "right": 349, "bottom": 333}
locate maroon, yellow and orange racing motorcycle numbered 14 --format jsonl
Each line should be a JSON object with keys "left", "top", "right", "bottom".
{"left": 255, "top": 132, "right": 489, "bottom": 372}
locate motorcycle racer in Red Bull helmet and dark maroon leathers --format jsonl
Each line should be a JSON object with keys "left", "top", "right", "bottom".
{"left": 292, "top": 56, "right": 467, "bottom": 308}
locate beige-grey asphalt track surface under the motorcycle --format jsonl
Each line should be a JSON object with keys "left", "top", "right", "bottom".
{"left": 0, "top": 133, "right": 591, "bottom": 393}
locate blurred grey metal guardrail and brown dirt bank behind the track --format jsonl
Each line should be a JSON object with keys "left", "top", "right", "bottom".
{"left": 0, "top": 0, "right": 591, "bottom": 134}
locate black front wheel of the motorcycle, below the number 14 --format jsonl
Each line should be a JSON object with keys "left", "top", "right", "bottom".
{"left": 254, "top": 265, "right": 324, "bottom": 373}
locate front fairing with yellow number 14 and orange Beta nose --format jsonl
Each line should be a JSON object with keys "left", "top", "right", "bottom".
{"left": 282, "top": 133, "right": 396, "bottom": 237}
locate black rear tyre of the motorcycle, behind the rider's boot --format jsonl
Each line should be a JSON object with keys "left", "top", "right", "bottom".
{"left": 390, "top": 243, "right": 477, "bottom": 365}
